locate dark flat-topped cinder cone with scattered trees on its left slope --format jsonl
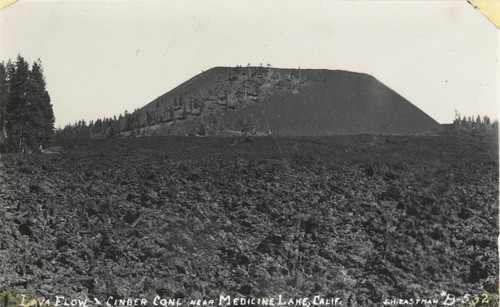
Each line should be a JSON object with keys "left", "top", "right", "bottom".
{"left": 122, "top": 67, "right": 439, "bottom": 136}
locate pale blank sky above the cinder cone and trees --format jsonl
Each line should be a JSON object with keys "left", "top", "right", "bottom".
{"left": 0, "top": 0, "right": 500, "bottom": 127}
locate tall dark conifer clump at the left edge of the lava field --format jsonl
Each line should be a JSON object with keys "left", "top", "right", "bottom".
{"left": 0, "top": 55, "right": 55, "bottom": 153}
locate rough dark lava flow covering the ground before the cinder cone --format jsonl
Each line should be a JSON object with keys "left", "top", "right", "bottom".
{"left": 0, "top": 136, "right": 498, "bottom": 306}
